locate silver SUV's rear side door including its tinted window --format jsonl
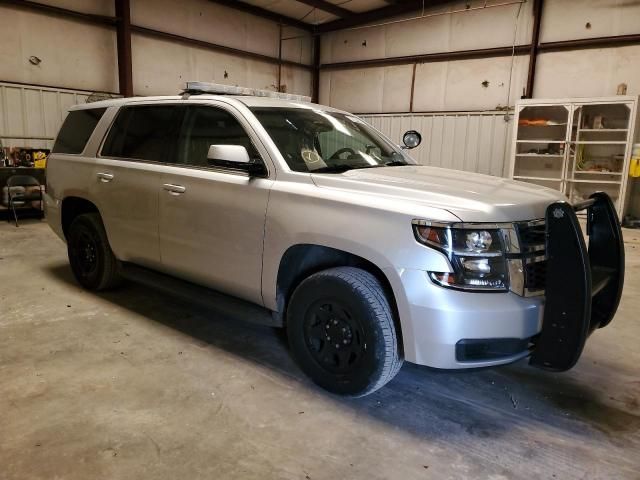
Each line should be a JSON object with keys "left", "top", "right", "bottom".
{"left": 93, "top": 104, "right": 182, "bottom": 268}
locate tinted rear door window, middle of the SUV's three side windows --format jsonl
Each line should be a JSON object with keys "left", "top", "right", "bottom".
{"left": 102, "top": 105, "right": 181, "bottom": 162}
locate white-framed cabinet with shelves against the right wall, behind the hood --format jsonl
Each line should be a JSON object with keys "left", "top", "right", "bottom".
{"left": 510, "top": 95, "right": 640, "bottom": 217}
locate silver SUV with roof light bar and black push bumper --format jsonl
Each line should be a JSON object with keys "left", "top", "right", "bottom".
{"left": 46, "top": 84, "right": 624, "bottom": 396}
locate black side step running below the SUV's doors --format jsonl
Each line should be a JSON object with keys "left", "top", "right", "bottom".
{"left": 121, "top": 263, "right": 283, "bottom": 327}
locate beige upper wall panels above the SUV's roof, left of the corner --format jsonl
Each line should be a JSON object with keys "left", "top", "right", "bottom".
{"left": 0, "top": 0, "right": 313, "bottom": 95}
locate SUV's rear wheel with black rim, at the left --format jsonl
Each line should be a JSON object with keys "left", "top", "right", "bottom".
{"left": 67, "top": 213, "right": 120, "bottom": 291}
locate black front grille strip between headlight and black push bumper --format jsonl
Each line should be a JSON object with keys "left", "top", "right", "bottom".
{"left": 517, "top": 222, "right": 547, "bottom": 295}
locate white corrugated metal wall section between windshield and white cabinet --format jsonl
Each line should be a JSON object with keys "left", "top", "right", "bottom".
{"left": 360, "top": 111, "right": 513, "bottom": 177}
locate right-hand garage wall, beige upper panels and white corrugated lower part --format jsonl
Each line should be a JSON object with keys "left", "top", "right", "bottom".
{"left": 320, "top": 0, "right": 640, "bottom": 176}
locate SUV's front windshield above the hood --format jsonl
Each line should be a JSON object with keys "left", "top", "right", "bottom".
{"left": 251, "top": 108, "right": 415, "bottom": 173}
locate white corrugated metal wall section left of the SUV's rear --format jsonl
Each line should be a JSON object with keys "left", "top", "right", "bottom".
{"left": 0, "top": 82, "right": 102, "bottom": 148}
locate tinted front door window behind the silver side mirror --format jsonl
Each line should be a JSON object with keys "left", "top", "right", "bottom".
{"left": 177, "top": 107, "right": 259, "bottom": 167}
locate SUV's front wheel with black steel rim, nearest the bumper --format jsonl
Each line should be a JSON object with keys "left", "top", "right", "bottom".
{"left": 287, "top": 267, "right": 403, "bottom": 397}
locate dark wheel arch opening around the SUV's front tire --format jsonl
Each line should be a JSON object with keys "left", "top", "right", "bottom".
{"left": 276, "top": 243, "right": 403, "bottom": 353}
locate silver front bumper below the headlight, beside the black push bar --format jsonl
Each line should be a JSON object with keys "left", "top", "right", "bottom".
{"left": 397, "top": 270, "right": 544, "bottom": 369}
